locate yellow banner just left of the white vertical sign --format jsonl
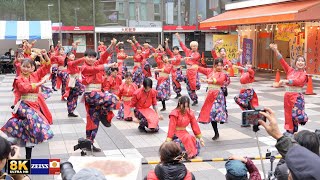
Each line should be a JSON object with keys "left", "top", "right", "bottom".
{"left": 213, "top": 35, "right": 238, "bottom": 60}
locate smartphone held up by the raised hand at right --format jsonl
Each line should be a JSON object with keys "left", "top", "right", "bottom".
{"left": 242, "top": 110, "right": 266, "bottom": 125}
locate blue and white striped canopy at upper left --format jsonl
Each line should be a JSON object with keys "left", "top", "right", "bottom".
{"left": 0, "top": 21, "right": 52, "bottom": 40}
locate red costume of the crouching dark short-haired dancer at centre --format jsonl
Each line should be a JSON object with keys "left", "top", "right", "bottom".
{"left": 130, "top": 87, "right": 159, "bottom": 132}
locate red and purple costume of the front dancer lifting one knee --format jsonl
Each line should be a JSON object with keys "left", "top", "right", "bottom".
{"left": 81, "top": 51, "right": 118, "bottom": 141}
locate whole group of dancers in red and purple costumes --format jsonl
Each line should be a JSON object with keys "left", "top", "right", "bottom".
{"left": 1, "top": 33, "right": 308, "bottom": 159}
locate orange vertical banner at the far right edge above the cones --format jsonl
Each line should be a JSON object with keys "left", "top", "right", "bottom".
{"left": 307, "top": 28, "right": 320, "bottom": 75}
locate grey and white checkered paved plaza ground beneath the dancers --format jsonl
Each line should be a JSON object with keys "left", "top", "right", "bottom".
{"left": 0, "top": 72, "right": 320, "bottom": 180}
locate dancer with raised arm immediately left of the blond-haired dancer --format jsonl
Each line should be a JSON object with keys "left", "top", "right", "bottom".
{"left": 165, "top": 39, "right": 183, "bottom": 99}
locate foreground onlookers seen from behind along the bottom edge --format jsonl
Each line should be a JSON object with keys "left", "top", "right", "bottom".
{"left": 0, "top": 108, "right": 320, "bottom": 180}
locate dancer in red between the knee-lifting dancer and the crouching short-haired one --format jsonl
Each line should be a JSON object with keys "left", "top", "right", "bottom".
{"left": 117, "top": 72, "right": 138, "bottom": 121}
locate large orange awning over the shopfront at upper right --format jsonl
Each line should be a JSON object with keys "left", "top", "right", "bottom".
{"left": 200, "top": 0, "right": 320, "bottom": 28}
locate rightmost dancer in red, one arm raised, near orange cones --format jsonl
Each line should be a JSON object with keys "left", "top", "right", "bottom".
{"left": 270, "top": 44, "right": 308, "bottom": 134}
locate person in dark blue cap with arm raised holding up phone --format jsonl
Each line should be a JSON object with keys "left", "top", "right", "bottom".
{"left": 258, "top": 108, "right": 320, "bottom": 180}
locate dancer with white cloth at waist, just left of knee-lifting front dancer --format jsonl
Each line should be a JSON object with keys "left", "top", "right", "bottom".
{"left": 63, "top": 51, "right": 86, "bottom": 117}
